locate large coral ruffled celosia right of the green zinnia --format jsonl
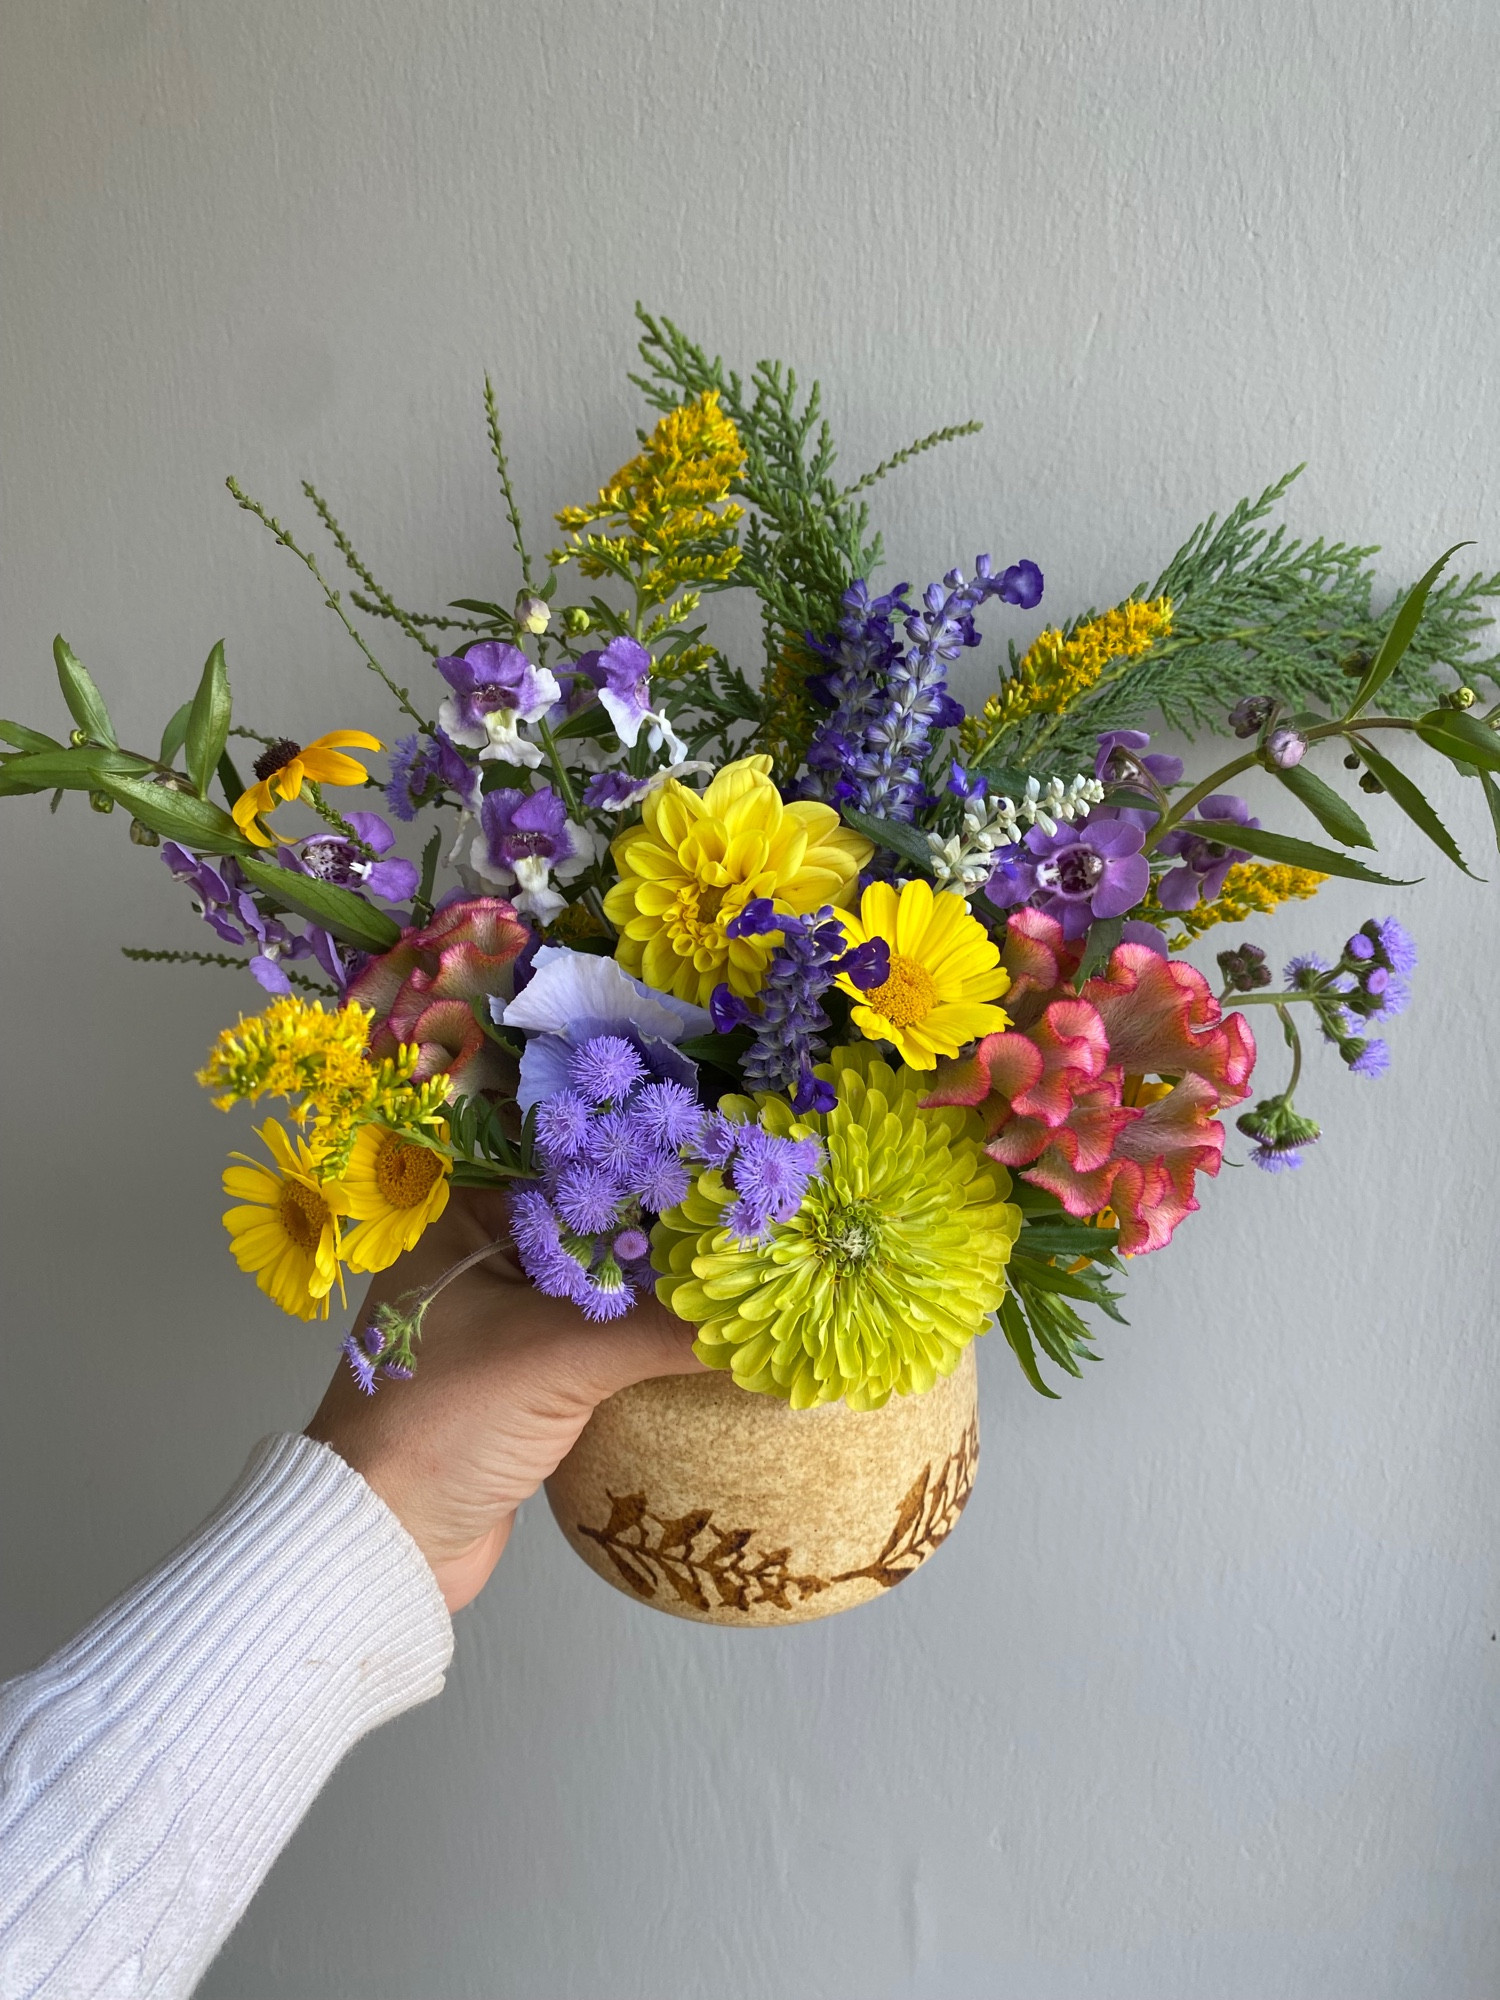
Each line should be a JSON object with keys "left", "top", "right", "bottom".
{"left": 924, "top": 910, "right": 1256, "bottom": 1254}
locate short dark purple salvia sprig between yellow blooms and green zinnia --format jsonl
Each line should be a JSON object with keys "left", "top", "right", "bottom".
{"left": 710, "top": 896, "right": 890, "bottom": 1120}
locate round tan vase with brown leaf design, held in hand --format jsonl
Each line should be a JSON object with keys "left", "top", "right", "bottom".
{"left": 546, "top": 1346, "right": 980, "bottom": 1626}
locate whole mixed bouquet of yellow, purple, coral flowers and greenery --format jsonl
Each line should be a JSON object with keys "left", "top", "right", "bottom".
{"left": 0, "top": 314, "right": 1500, "bottom": 1410}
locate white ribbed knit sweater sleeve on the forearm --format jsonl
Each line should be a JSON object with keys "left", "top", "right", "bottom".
{"left": 0, "top": 1438, "right": 454, "bottom": 2000}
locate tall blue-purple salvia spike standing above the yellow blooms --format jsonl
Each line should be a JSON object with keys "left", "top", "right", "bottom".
{"left": 808, "top": 556, "right": 1042, "bottom": 820}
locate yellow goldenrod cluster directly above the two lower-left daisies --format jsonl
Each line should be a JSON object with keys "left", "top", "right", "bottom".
{"left": 198, "top": 994, "right": 446, "bottom": 1172}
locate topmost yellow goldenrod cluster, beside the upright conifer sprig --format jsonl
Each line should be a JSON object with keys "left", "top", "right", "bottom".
{"left": 552, "top": 390, "right": 744, "bottom": 616}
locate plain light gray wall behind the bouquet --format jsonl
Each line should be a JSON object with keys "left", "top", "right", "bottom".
{"left": 0, "top": 0, "right": 1500, "bottom": 2000}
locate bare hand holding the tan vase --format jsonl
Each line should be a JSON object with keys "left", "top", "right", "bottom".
{"left": 306, "top": 1188, "right": 702, "bottom": 1612}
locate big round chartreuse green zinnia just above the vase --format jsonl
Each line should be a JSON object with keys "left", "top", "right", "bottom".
{"left": 652, "top": 1046, "right": 1020, "bottom": 1410}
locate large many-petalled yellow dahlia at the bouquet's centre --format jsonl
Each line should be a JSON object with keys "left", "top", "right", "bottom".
{"left": 604, "top": 756, "right": 876, "bottom": 1006}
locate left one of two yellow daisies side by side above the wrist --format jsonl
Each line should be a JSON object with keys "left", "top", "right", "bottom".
{"left": 224, "top": 1118, "right": 348, "bottom": 1320}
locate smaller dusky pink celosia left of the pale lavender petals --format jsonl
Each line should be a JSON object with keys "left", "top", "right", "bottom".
{"left": 348, "top": 896, "right": 530, "bottom": 1098}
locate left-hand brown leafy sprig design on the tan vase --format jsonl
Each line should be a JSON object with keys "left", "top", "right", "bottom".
{"left": 578, "top": 1494, "right": 828, "bottom": 1612}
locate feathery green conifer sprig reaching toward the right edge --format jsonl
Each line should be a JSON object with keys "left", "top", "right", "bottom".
{"left": 1004, "top": 466, "right": 1500, "bottom": 768}
